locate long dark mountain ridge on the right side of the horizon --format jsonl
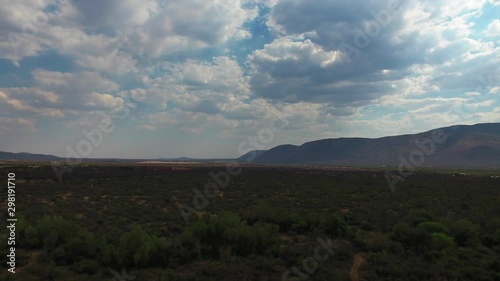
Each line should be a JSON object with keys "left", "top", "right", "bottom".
{"left": 252, "top": 123, "right": 500, "bottom": 168}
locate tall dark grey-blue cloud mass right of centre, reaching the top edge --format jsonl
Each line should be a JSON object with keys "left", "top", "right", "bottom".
{"left": 248, "top": 0, "right": 414, "bottom": 104}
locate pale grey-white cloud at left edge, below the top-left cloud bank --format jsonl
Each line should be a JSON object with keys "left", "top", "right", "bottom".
{"left": 0, "top": 69, "right": 124, "bottom": 128}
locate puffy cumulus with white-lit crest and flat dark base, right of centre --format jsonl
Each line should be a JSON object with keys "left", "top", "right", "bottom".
{"left": 248, "top": 36, "right": 396, "bottom": 104}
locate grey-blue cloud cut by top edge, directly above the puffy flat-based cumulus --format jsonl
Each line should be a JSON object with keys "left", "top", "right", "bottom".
{"left": 271, "top": 0, "right": 405, "bottom": 50}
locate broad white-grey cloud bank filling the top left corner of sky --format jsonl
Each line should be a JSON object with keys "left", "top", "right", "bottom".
{"left": 0, "top": 0, "right": 257, "bottom": 69}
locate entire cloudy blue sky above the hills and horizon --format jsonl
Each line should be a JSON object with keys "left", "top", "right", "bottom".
{"left": 0, "top": 0, "right": 500, "bottom": 158}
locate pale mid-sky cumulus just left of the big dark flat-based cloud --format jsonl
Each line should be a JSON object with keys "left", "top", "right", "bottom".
{"left": 129, "top": 56, "right": 250, "bottom": 114}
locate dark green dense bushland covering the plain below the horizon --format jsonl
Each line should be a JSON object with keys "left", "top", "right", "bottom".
{"left": 0, "top": 163, "right": 500, "bottom": 281}
